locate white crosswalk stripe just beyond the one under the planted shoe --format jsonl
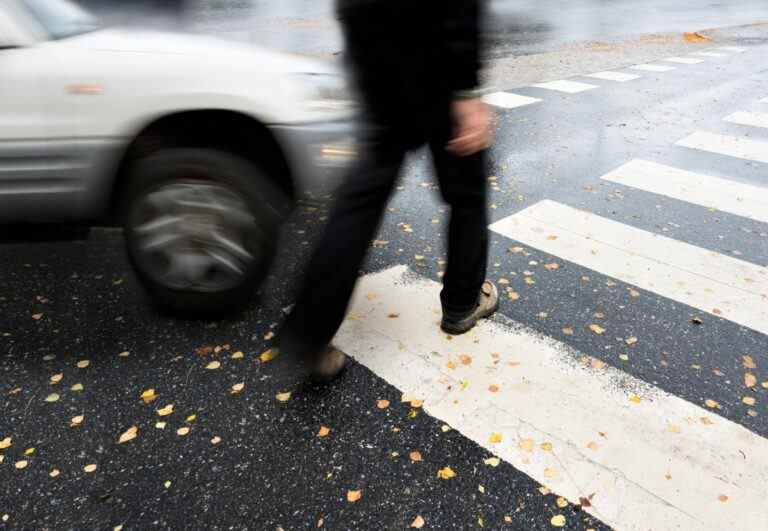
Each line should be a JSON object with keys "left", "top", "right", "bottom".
{"left": 490, "top": 200, "right": 768, "bottom": 334}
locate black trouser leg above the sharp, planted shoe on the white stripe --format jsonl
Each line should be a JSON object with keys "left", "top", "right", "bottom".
{"left": 430, "top": 134, "right": 488, "bottom": 315}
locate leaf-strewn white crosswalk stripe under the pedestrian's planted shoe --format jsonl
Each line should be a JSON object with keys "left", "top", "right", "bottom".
{"left": 334, "top": 266, "right": 768, "bottom": 531}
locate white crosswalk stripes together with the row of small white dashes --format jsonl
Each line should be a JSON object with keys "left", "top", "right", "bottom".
{"left": 346, "top": 47, "right": 768, "bottom": 531}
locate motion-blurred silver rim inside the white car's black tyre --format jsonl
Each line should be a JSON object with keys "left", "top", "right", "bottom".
{"left": 129, "top": 181, "right": 264, "bottom": 293}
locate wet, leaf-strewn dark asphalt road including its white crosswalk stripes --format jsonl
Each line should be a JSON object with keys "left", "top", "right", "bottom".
{"left": 0, "top": 3, "right": 768, "bottom": 530}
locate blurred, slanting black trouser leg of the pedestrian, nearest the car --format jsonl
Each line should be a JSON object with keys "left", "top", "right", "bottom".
{"left": 281, "top": 142, "right": 405, "bottom": 361}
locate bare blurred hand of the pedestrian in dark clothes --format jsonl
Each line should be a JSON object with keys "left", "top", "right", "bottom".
{"left": 447, "top": 98, "right": 493, "bottom": 157}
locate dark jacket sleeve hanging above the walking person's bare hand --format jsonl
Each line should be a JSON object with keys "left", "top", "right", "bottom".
{"left": 441, "top": 0, "right": 484, "bottom": 92}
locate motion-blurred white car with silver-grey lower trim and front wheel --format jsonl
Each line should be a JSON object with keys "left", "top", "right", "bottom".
{"left": 0, "top": 0, "right": 354, "bottom": 314}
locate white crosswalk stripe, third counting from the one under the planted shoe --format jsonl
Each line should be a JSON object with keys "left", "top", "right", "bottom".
{"left": 602, "top": 159, "right": 768, "bottom": 223}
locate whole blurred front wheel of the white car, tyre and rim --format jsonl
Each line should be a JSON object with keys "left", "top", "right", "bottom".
{"left": 123, "top": 149, "right": 290, "bottom": 317}
